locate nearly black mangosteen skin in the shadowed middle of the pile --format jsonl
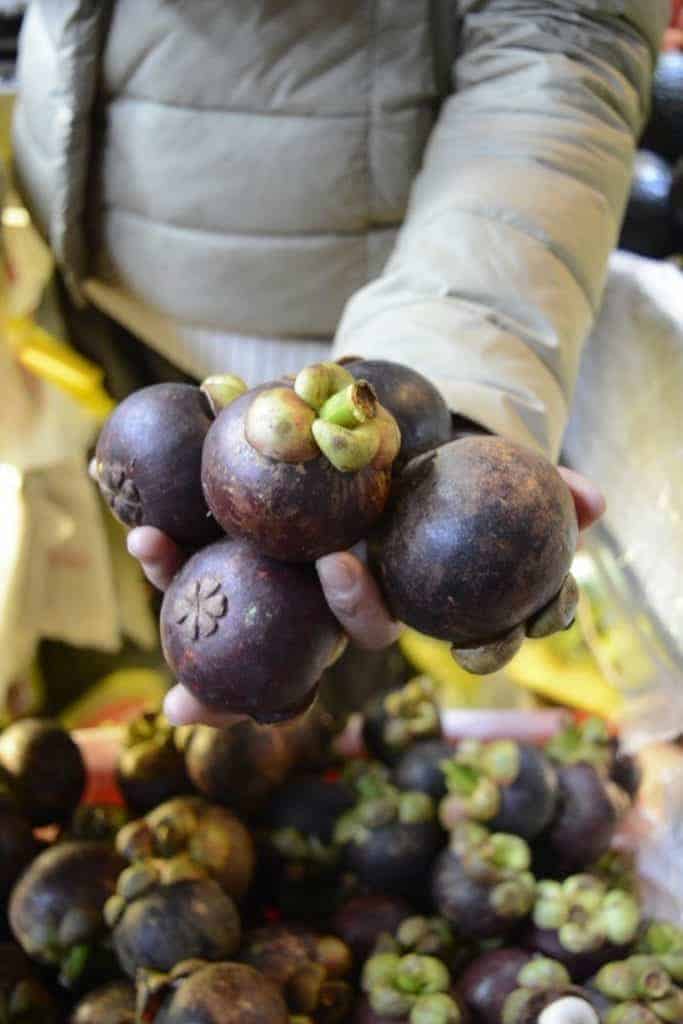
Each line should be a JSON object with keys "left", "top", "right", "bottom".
{"left": 264, "top": 775, "right": 354, "bottom": 845}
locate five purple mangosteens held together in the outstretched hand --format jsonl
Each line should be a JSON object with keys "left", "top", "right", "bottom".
{"left": 94, "top": 359, "right": 578, "bottom": 723}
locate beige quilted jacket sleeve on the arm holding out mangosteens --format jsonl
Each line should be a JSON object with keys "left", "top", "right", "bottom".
{"left": 336, "top": 0, "right": 669, "bottom": 458}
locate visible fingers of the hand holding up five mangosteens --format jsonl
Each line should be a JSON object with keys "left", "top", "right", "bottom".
{"left": 122, "top": 467, "right": 605, "bottom": 726}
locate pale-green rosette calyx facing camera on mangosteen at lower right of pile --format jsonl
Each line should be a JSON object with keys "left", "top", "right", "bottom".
{"left": 533, "top": 873, "right": 640, "bottom": 953}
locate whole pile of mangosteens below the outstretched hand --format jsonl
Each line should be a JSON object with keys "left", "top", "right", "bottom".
{"left": 0, "top": 696, "right": 683, "bottom": 1024}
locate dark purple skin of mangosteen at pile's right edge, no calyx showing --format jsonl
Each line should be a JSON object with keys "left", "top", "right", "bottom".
{"left": 543, "top": 761, "right": 618, "bottom": 873}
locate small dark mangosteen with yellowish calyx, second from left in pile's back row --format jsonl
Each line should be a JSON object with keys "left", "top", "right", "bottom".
{"left": 117, "top": 712, "right": 193, "bottom": 814}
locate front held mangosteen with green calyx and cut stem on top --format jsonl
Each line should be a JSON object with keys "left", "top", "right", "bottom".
{"left": 202, "top": 362, "right": 400, "bottom": 562}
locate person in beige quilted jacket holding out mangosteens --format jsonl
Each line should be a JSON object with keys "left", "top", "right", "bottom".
{"left": 14, "top": 0, "right": 670, "bottom": 722}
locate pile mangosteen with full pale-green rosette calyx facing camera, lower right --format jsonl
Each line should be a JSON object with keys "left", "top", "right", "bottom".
{"left": 524, "top": 873, "right": 641, "bottom": 982}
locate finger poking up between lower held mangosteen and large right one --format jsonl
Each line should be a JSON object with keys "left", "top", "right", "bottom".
{"left": 316, "top": 552, "right": 402, "bottom": 650}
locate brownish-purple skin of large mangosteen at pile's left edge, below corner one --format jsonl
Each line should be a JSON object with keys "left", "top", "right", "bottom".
{"left": 9, "top": 842, "right": 126, "bottom": 958}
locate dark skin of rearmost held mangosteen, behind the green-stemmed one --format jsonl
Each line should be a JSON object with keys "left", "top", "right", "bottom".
{"left": 346, "top": 359, "right": 451, "bottom": 469}
